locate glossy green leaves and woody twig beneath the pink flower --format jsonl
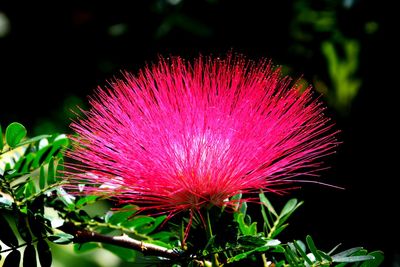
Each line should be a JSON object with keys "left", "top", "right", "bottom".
{"left": 0, "top": 122, "right": 383, "bottom": 267}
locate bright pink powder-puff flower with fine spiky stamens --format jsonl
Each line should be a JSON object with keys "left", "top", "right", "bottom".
{"left": 69, "top": 55, "right": 337, "bottom": 217}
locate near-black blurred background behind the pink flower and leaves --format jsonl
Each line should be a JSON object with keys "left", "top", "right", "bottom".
{"left": 0, "top": 0, "right": 400, "bottom": 266}
